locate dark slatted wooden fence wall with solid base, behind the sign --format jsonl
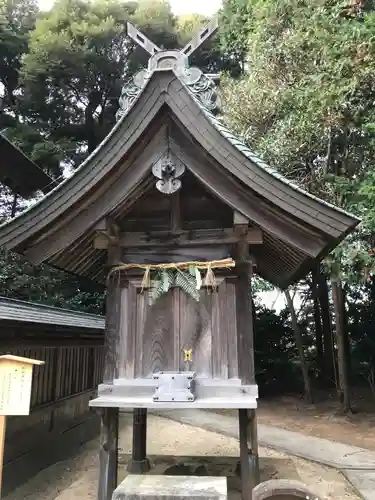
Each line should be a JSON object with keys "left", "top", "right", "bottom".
{"left": 0, "top": 298, "right": 104, "bottom": 494}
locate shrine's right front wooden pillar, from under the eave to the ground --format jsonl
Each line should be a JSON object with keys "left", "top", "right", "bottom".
{"left": 235, "top": 214, "right": 259, "bottom": 500}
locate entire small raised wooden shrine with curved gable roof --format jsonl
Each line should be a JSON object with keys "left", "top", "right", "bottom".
{"left": 0, "top": 17, "right": 359, "bottom": 500}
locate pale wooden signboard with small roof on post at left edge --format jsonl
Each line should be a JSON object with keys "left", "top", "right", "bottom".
{"left": 0, "top": 354, "right": 44, "bottom": 498}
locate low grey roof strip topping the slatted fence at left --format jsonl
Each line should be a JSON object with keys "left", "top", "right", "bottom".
{"left": 0, "top": 297, "right": 105, "bottom": 330}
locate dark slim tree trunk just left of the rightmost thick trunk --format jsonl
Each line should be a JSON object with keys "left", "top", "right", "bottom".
{"left": 317, "top": 270, "right": 336, "bottom": 385}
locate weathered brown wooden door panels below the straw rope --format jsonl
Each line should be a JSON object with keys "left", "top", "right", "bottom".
{"left": 119, "top": 278, "right": 238, "bottom": 379}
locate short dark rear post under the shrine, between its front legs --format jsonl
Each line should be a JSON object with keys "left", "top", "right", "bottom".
{"left": 128, "top": 408, "right": 150, "bottom": 474}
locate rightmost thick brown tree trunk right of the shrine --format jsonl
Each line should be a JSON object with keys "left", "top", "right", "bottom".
{"left": 332, "top": 279, "right": 351, "bottom": 412}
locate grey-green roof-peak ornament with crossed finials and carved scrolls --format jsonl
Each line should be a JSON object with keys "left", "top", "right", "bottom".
{"left": 116, "top": 16, "right": 220, "bottom": 120}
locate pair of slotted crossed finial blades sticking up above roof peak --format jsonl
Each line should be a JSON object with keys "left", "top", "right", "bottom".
{"left": 128, "top": 16, "right": 219, "bottom": 57}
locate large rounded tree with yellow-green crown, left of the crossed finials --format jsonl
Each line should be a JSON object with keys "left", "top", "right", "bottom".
{"left": 22, "top": 0, "right": 138, "bottom": 165}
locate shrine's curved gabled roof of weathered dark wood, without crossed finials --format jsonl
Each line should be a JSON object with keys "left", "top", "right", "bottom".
{"left": 0, "top": 51, "right": 359, "bottom": 288}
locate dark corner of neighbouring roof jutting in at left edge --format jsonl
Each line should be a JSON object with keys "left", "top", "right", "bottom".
{"left": 0, "top": 133, "right": 54, "bottom": 198}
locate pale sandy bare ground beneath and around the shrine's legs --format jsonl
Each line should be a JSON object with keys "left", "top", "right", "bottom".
{"left": 4, "top": 416, "right": 359, "bottom": 500}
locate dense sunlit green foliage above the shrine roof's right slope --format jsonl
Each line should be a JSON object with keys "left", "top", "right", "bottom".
{"left": 222, "top": 0, "right": 375, "bottom": 282}
